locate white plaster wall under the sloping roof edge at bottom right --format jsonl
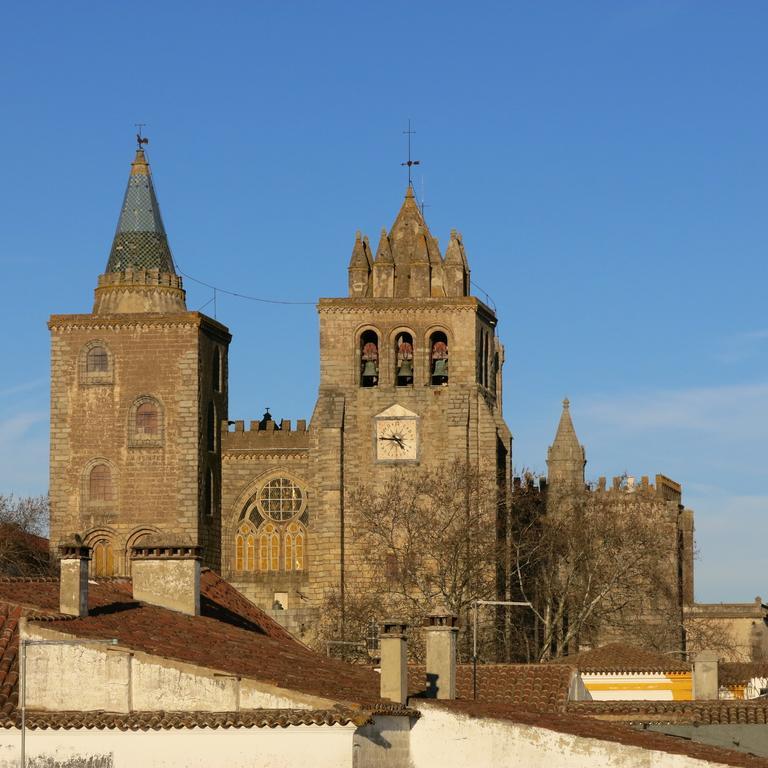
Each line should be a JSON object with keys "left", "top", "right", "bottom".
{"left": 410, "top": 704, "right": 736, "bottom": 768}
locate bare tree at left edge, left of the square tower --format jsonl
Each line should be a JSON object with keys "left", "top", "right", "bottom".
{"left": 0, "top": 494, "right": 51, "bottom": 576}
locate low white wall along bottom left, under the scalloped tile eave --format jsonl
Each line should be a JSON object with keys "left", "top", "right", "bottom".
{"left": 0, "top": 725, "right": 355, "bottom": 768}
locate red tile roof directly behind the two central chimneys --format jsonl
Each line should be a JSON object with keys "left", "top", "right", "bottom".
{"left": 408, "top": 664, "right": 577, "bottom": 712}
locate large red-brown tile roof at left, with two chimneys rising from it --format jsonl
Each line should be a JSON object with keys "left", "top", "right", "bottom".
{"left": 0, "top": 570, "right": 389, "bottom": 714}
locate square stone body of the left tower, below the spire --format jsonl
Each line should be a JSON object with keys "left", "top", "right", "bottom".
{"left": 49, "top": 312, "right": 230, "bottom": 573}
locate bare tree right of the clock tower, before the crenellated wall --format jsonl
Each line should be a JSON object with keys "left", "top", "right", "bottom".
{"left": 511, "top": 483, "right": 682, "bottom": 661}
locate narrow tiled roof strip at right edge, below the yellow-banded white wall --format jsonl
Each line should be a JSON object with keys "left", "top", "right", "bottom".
{"left": 567, "top": 699, "right": 768, "bottom": 725}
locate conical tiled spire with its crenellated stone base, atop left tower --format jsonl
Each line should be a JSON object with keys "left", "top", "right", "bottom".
{"left": 93, "top": 147, "right": 186, "bottom": 314}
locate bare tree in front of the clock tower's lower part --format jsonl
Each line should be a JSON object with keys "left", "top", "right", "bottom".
{"left": 321, "top": 461, "right": 503, "bottom": 659}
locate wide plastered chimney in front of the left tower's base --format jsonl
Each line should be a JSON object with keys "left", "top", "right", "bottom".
{"left": 131, "top": 541, "right": 202, "bottom": 616}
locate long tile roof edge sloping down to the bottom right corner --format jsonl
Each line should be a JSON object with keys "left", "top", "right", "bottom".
{"left": 434, "top": 699, "right": 768, "bottom": 768}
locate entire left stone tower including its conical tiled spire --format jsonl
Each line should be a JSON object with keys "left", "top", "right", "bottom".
{"left": 48, "top": 145, "right": 231, "bottom": 575}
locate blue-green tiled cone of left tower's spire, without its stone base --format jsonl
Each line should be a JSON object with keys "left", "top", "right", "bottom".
{"left": 106, "top": 149, "right": 176, "bottom": 275}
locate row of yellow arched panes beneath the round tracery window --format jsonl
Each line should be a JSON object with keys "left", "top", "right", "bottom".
{"left": 235, "top": 520, "right": 307, "bottom": 573}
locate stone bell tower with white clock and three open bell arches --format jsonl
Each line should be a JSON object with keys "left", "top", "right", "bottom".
{"left": 310, "top": 185, "right": 511, "bottom": 595}
